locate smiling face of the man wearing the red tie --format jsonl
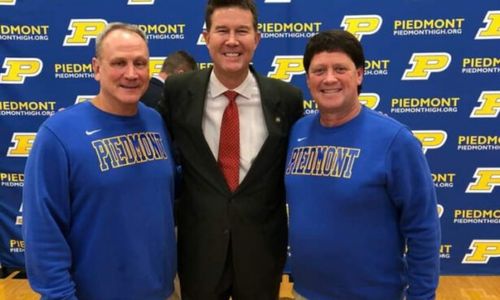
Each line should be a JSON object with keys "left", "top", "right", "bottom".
{"left": 203, "top": 7, "right": 260, "bottom": 79}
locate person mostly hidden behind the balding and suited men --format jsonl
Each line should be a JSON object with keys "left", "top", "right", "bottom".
{"left": 141, "top": 51, "right": 197, "bottom": 108}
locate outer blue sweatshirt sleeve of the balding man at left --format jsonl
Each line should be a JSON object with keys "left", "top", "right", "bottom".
{"left": 23, "top": 125, "right": 77, "bottom": 300}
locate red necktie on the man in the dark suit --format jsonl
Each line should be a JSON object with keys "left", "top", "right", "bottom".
{"left": 218, "top": 91, "right": 240, "bottom": 192}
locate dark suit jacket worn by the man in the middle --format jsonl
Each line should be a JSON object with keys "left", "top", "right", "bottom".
{"left": 159, "top": 69, "right": 303, "bottom": 299}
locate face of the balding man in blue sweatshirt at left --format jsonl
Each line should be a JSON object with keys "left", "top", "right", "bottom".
{"left": 92, "top": 29, "right": 149, "bottom": 114}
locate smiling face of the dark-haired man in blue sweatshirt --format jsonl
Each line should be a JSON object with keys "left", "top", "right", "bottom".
{"left": 306, "top": 51, "right": 363, "bottom": 113}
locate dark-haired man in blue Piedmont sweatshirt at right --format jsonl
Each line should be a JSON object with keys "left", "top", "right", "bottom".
{"left": 285, "top": 30, "right": 440, "bottom": 300}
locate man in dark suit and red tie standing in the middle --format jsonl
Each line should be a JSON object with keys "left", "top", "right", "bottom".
{"left": 159, "top": 0, "right": 303, "bottom": 300}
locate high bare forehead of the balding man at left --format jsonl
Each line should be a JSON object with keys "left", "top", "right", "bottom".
{"left": 101, "top": 29, "right": 148, "bottom": 57}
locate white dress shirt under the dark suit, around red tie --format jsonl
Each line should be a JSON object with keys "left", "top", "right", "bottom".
{"left": 202, "top": 72, "right": 268, "bottom": 183}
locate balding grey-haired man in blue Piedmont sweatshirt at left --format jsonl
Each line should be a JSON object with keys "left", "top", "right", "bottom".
{"left": 23, "top": 23, "right": 176, "bottom": 300}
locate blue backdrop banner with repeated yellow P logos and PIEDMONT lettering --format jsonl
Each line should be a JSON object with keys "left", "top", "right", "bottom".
{"left": 0, "top": 0, "right": 500, "bottom": 274}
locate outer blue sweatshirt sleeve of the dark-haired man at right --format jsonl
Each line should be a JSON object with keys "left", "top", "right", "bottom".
{"left": 387, "top": 128, "right": 441, "bottom": 300}
